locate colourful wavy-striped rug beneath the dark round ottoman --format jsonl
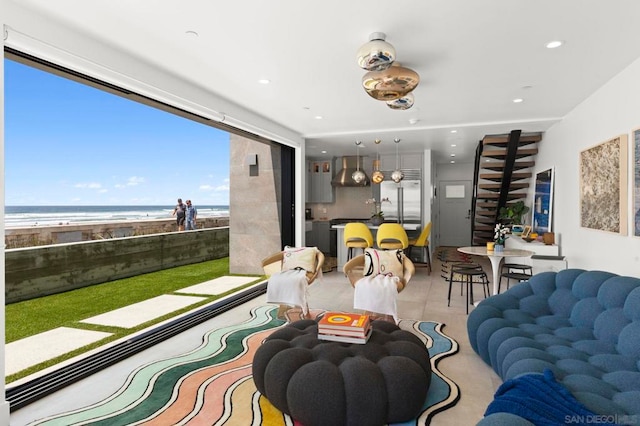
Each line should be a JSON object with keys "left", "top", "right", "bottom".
{"left": 31, "top": 306, "right": 460, "bottom": 426}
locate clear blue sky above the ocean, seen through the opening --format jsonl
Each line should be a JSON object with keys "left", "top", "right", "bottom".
{"left": 4, "top": 60, "right": 229, "bottom": 205}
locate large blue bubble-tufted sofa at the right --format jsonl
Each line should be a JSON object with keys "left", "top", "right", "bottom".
{"left": 467, "top": 269, "right": 640, "bottom": 424}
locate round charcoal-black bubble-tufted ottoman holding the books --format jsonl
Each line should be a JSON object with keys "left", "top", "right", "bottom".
{"left": 252, "top": 320, "right": 431, "bottom": 426}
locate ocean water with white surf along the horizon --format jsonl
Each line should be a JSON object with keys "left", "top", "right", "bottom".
{"left": 4, "top": 205, "right": 229, "bottom": 228}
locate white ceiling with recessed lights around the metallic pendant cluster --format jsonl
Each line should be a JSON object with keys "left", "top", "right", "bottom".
{"left": 10, "top": 0, "right": 640, "bottom": 163}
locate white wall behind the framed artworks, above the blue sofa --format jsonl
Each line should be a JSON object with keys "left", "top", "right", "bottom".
{"left": 536, "top": 59, "right": 640, "bottom": 277}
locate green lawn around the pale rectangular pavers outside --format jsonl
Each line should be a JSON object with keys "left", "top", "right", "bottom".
{"left": 5, "top": 258, "right": 262, "bottom": 382}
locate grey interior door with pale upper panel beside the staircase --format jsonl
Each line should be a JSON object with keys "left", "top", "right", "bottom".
{"left": 437, "top": 180, "right": 472, "bottom": 247}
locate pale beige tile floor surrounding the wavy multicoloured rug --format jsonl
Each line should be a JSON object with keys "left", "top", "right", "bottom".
{"left": 11, "top": 248, "right": 501, "bottom": 426}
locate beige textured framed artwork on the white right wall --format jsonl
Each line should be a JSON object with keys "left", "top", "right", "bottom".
{"left": 580, "top": 135, "right": 628, "bottom": 235}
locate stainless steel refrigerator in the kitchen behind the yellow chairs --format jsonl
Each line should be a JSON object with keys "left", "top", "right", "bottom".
{"left": 380, "top": 179, "right": 422, "bottom": 223}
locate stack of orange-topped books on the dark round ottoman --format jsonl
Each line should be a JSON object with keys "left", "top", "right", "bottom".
{"left": 318, "top": 312, "right": 371, "bottom": 344}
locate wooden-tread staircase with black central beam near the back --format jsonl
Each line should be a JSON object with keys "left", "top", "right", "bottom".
{"left": 471, "top": 130, "right": 542, "bottom": 245}
